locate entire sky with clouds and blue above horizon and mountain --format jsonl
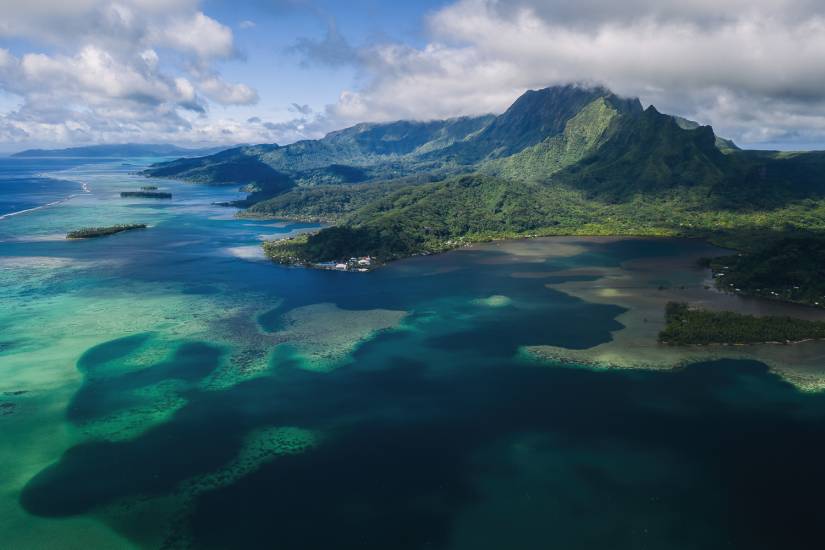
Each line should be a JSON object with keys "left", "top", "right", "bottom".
{"left": 0, "top": 0, "right": 825, "bottom": 152}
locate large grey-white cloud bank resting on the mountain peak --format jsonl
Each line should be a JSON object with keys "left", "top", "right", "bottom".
{"left": 330, "top": 0, "right": 825, "bottom": 148}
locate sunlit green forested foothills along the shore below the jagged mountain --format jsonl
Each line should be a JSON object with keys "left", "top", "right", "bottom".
{"left": 262, "top": 174, "right": 825, "bottom": 266}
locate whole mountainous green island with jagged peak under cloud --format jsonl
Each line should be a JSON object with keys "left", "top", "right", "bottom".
{"left": 145, "top": 86, "right": 825, "bottom": 261}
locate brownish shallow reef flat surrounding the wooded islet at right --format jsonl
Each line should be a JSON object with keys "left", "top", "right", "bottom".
{"left": 498, "top": 238, "right": 825, "bottom": 391}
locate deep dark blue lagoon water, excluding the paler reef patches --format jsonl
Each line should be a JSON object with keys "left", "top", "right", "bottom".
{"left": 0, "top": 157, "right": 825, "bottom": 550}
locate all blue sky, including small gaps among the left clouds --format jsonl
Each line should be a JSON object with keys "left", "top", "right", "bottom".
{"left": 0, "top": 0, "right": 458, "bottom": 151}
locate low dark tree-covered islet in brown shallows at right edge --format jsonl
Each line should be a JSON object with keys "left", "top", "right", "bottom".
{"left": 659, "top": 302, "right": 825, "bottom": 346}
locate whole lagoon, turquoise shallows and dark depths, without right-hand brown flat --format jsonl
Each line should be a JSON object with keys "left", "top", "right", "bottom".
{"left": 0, "top": 157, "right": 825, "bottom": 549}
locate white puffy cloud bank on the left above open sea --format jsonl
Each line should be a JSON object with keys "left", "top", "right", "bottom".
{"left": 0, "top": 0, "right": 258, "bottom": 149}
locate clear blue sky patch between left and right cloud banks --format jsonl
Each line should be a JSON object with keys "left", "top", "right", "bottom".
{"left": 204, "top": 0, "right": 443, "bottom": 123}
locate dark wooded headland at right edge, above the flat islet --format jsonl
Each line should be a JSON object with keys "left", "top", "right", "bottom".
{"left": 711, "top": 236, "right": 825, "bottom": 307}
